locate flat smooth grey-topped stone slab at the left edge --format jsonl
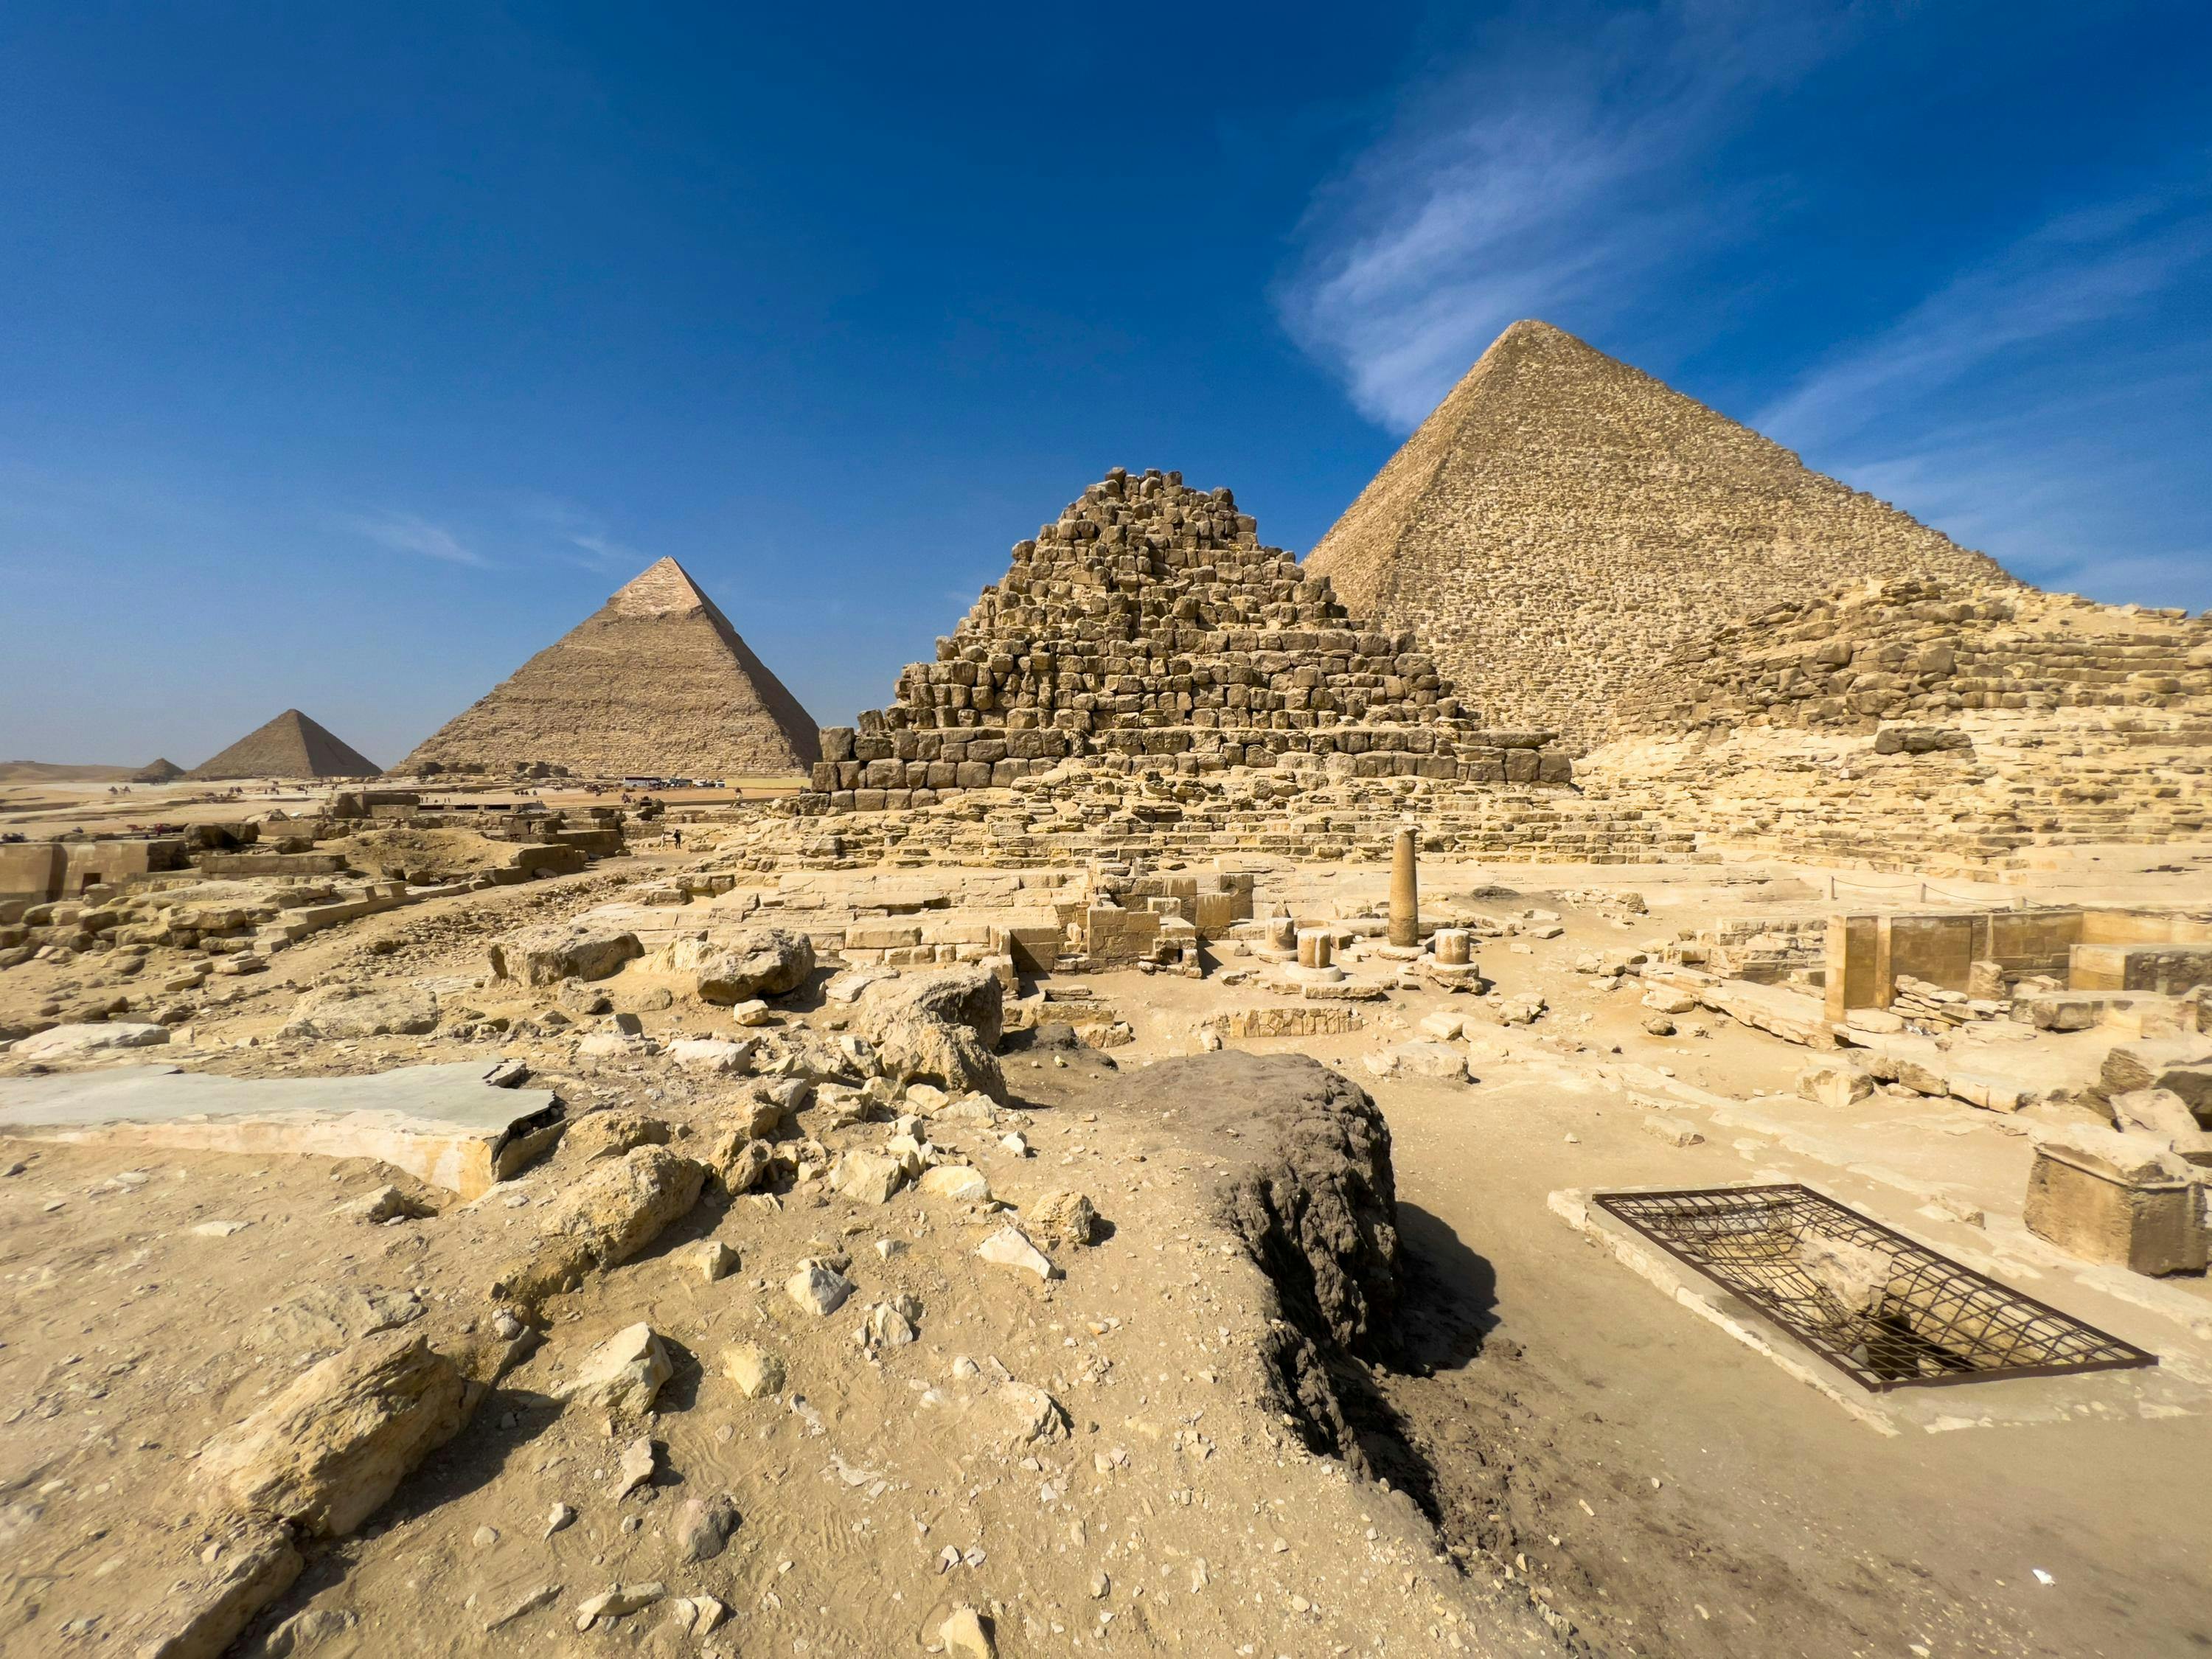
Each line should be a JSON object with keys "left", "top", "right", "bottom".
{"left": 0, "top": 1060, "right": 566, "bottom": 1199}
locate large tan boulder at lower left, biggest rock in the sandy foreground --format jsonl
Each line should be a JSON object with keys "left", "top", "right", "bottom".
{"left": 199, "top": 1332, "right": 465, "bottom": 1537}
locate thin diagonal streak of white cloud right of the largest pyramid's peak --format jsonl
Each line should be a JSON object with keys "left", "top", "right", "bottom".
{"left": 1754, "top": 184, "right": 2212, "bottom": 447}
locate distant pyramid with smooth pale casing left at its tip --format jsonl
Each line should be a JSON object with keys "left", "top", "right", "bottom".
{"left": 392, "top": 560, "right": 821, "bottom": 779}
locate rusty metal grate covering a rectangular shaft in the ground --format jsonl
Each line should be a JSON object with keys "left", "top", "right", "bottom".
{"left": 1593, "top": 1183, "right": 2159, "bottom": 1391}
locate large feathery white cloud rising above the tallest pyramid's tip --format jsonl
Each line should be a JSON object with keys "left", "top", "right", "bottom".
{"left": 1276, "top": 0, "right": 1854, "bottom": 431}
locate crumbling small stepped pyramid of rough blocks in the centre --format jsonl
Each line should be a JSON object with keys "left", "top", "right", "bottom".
{"left": 814, "top": 467, "right": 1571, "bottom": 812}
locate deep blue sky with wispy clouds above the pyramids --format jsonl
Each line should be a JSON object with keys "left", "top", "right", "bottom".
{"left": 0, "top": 0, "right": 2212, "bottom": 765}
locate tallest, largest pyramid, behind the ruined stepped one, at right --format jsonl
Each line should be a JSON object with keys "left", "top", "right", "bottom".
{"left": 1305, "top": 323, "right": 2017, "bottom": 745}
